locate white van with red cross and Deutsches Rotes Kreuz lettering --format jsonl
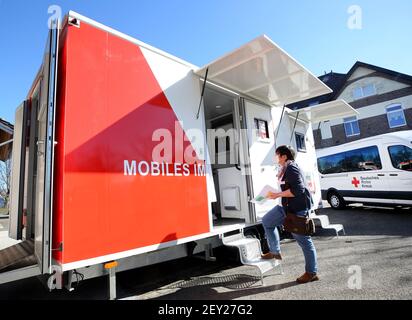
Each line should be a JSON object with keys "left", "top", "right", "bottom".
{"left": 316, "top": 130, "right": 412, "bottom": 209}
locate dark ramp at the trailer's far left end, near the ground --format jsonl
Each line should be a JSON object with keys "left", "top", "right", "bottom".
{"left": 0, "top": 240, "right": 37, "bottom": 272}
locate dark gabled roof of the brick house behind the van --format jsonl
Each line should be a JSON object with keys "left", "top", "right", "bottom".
{"left": 287, "top": 61, "right": 412, "bottom": 110}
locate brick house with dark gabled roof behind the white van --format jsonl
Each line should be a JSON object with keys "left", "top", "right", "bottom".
{"left": 288, "top": 61, "right": 412, "bottom": 149}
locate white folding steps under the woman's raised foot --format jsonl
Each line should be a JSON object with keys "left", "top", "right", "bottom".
{"left": 222, "top": 231, "right": 283, "bottom": 285}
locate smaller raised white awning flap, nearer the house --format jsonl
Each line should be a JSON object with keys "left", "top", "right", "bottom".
{"left": 289, "top": 100, "right": 359, "bottom": 123}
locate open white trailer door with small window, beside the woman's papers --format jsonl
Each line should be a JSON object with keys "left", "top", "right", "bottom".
{"left": 243, "top": 99, "right": 278, "bottom": 221}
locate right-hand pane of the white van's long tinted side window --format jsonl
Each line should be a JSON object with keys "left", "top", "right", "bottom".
{"left": 345, "top": 146, "right": 382, "bottom": 172}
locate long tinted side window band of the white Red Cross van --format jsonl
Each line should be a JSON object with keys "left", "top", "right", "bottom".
{"left": 318, "top": 146, "right": 382, "bottom": 174}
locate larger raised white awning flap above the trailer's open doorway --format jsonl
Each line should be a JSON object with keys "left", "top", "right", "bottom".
{"left": 195, "top": 35, "right": 332, "bottom": 106}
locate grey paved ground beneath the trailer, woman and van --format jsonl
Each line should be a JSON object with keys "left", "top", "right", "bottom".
{"left": 0, "top": 204, "right": 412, "bottom": 300}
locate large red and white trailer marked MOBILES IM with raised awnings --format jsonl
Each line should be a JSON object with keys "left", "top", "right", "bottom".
{"left": 0, "top": 12, "right": 354, "bottom": 296}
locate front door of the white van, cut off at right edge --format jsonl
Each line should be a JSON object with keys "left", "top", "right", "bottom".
{"left": 383, "top": 143, "right": 412, "bottom": 205}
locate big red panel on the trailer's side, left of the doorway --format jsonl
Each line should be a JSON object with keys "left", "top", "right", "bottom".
{"left": 53, "top": 23, "right": 210, "bottom": 263}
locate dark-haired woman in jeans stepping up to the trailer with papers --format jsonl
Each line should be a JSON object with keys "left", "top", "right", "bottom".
{"left": 262, "top": 146, "right": 319, "bottom": 283}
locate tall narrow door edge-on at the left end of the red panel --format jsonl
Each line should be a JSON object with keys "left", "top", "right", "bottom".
{"left": 34, "top": 23, "right": 59, "bottom": 273}
